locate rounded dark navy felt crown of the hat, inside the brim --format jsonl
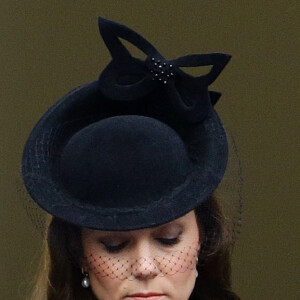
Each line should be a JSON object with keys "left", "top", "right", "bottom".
{"left": 60, "top": 115, "right": 190, "bottom": 208}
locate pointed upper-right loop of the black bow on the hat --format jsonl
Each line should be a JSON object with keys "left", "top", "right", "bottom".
{"left": 173, "top": 53, "right": 231, "bottom": 86}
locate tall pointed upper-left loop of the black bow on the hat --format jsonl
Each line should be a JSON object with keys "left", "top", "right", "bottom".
{"left": 98, "top": 17, "right": 162, "bottom": 60}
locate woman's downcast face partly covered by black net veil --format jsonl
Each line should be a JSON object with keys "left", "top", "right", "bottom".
{"left": 82, "top": 211, "right": 202, "bottom": 300}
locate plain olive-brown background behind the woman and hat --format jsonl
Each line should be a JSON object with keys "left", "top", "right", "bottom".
{"left": 0, "top": 0, "right": 300, "bottom": 300}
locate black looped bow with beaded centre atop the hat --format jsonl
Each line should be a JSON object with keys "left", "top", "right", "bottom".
{"left": 99, "top": 18, "right": 231, "bottom": 123}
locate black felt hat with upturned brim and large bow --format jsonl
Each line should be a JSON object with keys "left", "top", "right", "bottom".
{"left": 22, "top": 18, "right": 231, "bottom": 230}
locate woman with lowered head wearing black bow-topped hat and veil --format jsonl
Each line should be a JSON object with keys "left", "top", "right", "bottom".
{"left": 22, "top": 18, "right": 239, "bottom": 300}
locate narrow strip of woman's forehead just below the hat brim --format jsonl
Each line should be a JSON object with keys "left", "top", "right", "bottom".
{"left": 83, "top": 211, "right": 196, "bottom": 235}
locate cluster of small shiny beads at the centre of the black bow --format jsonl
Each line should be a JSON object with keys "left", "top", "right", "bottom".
{"left": 149, "top": 57, "right": 174, "bottom": 84}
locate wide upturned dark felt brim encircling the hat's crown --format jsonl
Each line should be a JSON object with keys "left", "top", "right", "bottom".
{"left": 22, "top": 81, "right": 228, "bottom": 231}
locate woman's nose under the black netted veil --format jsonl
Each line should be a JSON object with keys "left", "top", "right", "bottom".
{"left": 131, "top": 241, "right": 160, "bottom": 280}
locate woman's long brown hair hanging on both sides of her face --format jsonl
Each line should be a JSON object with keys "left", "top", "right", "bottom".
{"left": 28, "top": 195, "right": 240, "bottom": 300}
